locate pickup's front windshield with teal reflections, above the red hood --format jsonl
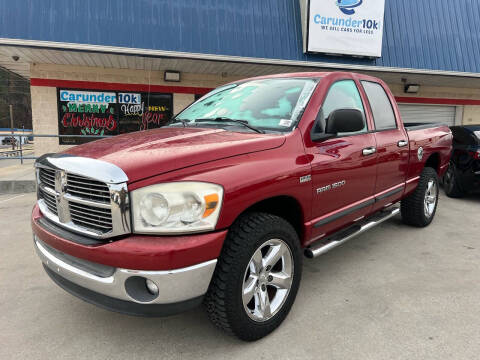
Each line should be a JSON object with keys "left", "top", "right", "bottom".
{"left": 173, "top": 78, "right": 317, "bottom": 132}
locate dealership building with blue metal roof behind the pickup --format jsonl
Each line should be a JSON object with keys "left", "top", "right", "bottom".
{"left": 0, "top": 0, "right": 480, "bottom": 155}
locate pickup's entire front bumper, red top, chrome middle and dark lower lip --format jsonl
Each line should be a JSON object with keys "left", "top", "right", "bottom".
{"left": 32, "top": 207, "right": 226, "bottom": 316}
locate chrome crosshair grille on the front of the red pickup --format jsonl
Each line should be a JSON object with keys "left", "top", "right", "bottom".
{"left": 35, "top": 155, "right": 130, "bottom": 238}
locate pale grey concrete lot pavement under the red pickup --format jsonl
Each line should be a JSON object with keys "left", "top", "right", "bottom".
{"left": 0, "top": 194, "right": 480, "bottom": 360}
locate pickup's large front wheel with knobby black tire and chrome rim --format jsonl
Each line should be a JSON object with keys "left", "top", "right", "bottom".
{"left": 204, "top": 212, "right": 303, "bottom": 341}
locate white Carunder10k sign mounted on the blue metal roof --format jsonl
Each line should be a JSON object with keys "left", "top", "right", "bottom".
{"left": 307, "top": 0, "right": 385, "bottom": 57}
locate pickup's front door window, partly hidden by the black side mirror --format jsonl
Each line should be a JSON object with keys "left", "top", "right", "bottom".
{"left": 318, "top": 80, "right": 367, "bottom": 136}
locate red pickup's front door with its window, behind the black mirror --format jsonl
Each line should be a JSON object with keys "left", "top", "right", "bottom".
{"left": 306, "top": 79, "right": 377, "bottom": 240}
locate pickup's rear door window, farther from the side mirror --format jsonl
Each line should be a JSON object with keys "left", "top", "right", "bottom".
{"left": 362, "top": 81, "right": 397, "bottom": 130}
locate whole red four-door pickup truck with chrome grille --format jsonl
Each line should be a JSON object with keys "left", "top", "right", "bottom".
{"left": 32, "top": 72, "right": 452, "bottom": 340}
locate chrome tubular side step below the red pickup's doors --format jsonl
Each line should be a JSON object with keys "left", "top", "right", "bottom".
{"left": 305, "top": 208, "right": 400, "bottom": 259}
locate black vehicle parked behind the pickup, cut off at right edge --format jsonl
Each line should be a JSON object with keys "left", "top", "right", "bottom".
{"left": 443, "top": 125, "right": 480, "bottom": 197}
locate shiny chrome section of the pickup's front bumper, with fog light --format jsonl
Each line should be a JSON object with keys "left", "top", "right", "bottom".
{"left": 34, "top": 236, "right": 217, "bottom": 304}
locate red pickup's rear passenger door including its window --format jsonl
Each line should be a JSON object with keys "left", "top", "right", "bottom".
{"left": 361, "top": 80, "right": 409, "bottom": 210}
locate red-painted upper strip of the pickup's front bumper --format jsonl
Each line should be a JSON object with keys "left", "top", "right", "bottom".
{"left": 31, "top": 205, "right": 227, "bottom": 271}
